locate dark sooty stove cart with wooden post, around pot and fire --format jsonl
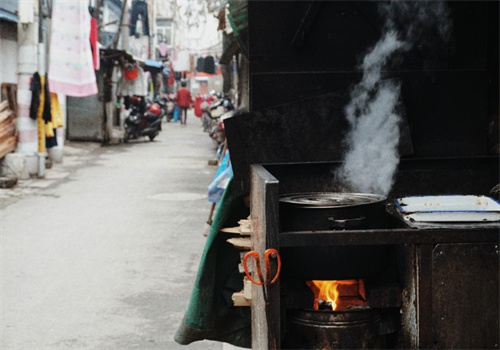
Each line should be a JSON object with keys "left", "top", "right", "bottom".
{"left": 250, "top": 158, "right": 499, "bottom": 349}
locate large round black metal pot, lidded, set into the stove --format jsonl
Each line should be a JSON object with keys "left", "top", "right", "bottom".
{"left": 280, "top": 192, "right": 388, "bottom": 280}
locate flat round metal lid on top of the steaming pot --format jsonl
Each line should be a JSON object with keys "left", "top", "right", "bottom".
{"left": 280, "top": 192, "right": 386, "bottom": 208}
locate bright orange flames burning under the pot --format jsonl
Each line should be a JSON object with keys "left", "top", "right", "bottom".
{"left": 306, "top": 279, "right": 366, "bottom": 310}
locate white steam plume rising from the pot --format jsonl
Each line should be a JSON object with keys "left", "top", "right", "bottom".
{"left": 335, "top": 1, "right": 451, "bottom": 195}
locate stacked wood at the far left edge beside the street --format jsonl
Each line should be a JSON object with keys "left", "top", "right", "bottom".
{"left": 0, "top": 84, "right": 17, "bottom": 158}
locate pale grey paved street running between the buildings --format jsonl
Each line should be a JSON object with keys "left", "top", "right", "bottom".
{"left": 0, "top": 114, "right": 230, "bottom": 350}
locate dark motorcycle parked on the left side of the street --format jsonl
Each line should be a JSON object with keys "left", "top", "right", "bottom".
{"left": 123, "top": 97, "right": 166, "bottom": 143}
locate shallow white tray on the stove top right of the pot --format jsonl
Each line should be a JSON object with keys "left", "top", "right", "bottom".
{"left": 395, "top": 195, "right": 500, "bottom": 222}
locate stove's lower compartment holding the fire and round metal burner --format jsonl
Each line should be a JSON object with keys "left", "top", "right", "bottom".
{"left": 282, "top": 275, "right": 402, "bottom": 350}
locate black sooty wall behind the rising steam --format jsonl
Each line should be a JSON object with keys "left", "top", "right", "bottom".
{"left": 248, "top": 1, "right": 499, "bottom": 157}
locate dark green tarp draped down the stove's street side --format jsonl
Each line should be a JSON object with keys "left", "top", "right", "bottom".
{"left": 175, "top": 180, "right": 251, "bottom": 348}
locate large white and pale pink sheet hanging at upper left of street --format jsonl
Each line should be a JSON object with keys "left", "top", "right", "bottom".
{"left": 49, "top": 0, "right": 98, "bottom": 97}
